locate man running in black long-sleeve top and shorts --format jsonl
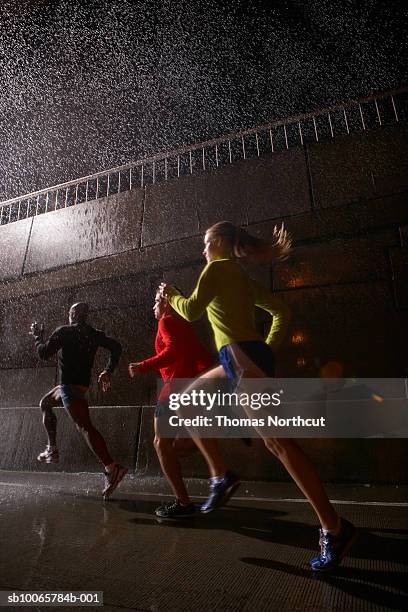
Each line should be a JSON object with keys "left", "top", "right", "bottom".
{"left": 30, "top": 302, "right": 128, "bottom": 499}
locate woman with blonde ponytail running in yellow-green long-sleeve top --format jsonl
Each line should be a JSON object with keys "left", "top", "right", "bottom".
{"left": 160, "top": 221, "right": 357, "bottom": 571}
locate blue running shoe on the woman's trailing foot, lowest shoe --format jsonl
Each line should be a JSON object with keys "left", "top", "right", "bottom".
{"left": 310, "top": 518, "right": 358, "bottom": 572}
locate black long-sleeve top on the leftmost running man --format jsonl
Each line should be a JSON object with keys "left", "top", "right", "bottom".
{"left": 34, "top": 323, "right": 122, "bottom": 387}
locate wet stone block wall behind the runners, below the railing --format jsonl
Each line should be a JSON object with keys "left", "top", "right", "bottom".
{"left": 0, "top": 123, "right": 408, "bottom": 481}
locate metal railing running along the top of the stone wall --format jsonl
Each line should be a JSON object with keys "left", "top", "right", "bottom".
{"left": 0, "top": 87, "right": 408, "bottom": 225}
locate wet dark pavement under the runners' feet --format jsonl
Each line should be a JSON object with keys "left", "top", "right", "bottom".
{"left": 0, "top": 472, "right": 408, "bottom": 612}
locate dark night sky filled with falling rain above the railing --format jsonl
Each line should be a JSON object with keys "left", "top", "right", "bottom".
{"left": 0, "top": 0, "right": 408, "bottom": 199}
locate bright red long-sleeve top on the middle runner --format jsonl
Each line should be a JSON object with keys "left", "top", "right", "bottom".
{"left": 139, "top": 314, "right": 214, "bottom": 400}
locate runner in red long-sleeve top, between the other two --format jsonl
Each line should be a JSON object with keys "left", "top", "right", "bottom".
{"left": 129, "top": 293, "right": 222, "bottom": 518}
